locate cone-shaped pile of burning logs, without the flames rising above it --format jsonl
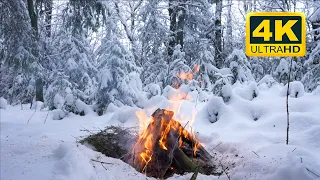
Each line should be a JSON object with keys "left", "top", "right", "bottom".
{"left": 123, "top": 109, "right": 216, "bottom": 178}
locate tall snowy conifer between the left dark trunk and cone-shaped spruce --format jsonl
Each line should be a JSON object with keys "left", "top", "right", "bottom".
{"left": 45, "top": 1, "right": 102, "bottom": 108}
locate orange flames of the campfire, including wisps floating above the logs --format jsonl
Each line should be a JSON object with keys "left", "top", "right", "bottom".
{"left": 133, "top": 64, "right": 201, "bottom": 172}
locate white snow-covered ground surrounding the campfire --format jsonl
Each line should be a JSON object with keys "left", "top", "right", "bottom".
{"left": 0, "top": 84, "right": 320, "bottom": 180}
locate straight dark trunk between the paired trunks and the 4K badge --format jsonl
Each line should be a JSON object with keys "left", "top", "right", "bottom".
{"left": 214, "top": 0, "right": 223, "bottom": 68}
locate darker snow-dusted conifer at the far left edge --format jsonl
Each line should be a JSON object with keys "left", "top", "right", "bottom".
{"left": 0, "top": 0, "right": 42, "bottom": 104}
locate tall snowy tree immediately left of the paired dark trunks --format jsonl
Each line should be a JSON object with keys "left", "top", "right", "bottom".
{"left": 138, "top": 0, "right": 169, "bottom": 88}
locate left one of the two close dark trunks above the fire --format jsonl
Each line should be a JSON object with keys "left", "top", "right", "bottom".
{"left": 168, "top": 0, "right": 177, "bottom": 57}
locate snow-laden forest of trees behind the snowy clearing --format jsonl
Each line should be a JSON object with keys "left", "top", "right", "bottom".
{"left": 0, "top": 0, "right": 320, "bottom": 116}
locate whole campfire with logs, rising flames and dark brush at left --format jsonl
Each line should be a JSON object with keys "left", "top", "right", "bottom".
{"left": 83, "top": 65, "right": 216, "bottom": 178}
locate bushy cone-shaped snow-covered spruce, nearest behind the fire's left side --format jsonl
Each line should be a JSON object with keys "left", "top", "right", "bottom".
{"left": 95, "top": 34, "right": 142, "bottom": 114}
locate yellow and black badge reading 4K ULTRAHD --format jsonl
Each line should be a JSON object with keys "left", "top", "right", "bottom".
{"left": 246, "top": 12, "right": 306, "bottom": 56}
